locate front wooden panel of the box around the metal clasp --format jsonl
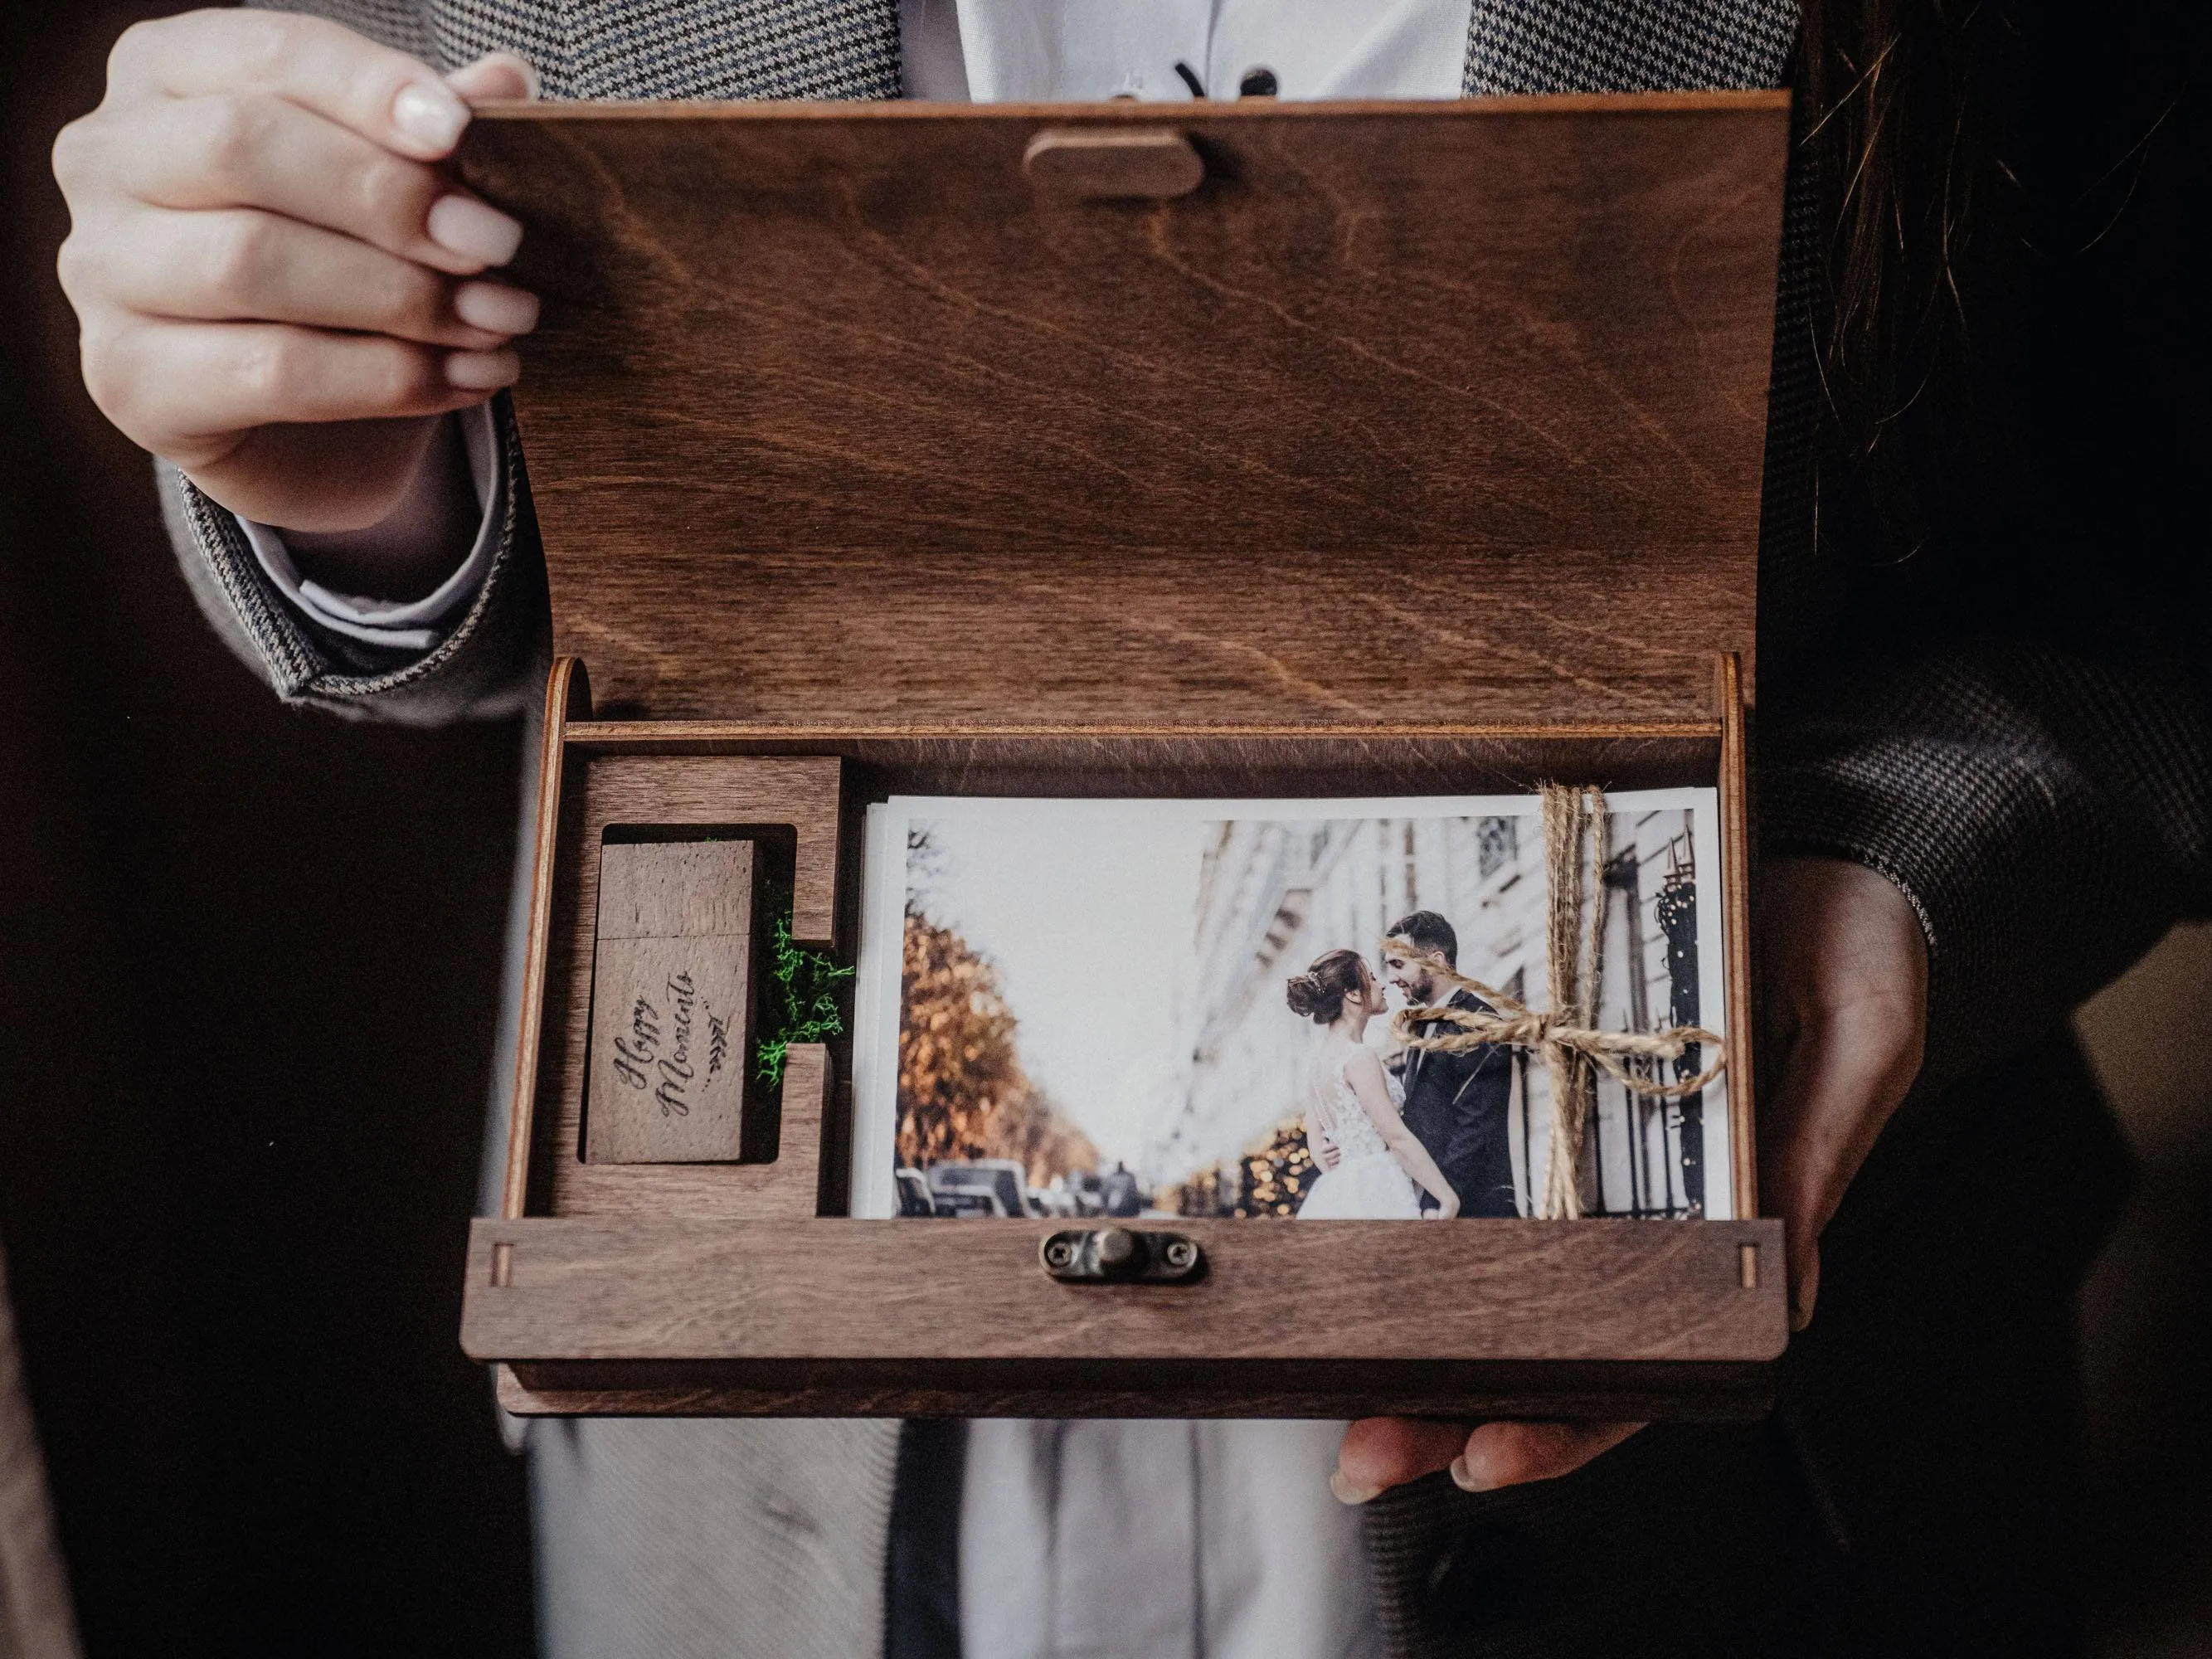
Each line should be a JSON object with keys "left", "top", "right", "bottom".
{"left": 462, "top": 1219, "right": 1787, "bottom": 1413}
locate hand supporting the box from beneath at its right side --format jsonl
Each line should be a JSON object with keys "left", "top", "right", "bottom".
{"left": 1330, "top": 859, "right": 1929, "bottom": 1504}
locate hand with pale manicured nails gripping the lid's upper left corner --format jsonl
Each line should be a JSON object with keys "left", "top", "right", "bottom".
{"left": 53, "top": 11, "right": 537, "bottom": 562}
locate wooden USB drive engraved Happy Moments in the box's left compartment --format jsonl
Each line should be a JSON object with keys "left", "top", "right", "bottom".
{"left": 584, "top": 840, "right": 756, "bottom": 1164}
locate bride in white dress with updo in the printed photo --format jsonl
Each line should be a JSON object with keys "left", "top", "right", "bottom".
{"left": 1287, "top": 951, "right": 1460, "bottom": 1221}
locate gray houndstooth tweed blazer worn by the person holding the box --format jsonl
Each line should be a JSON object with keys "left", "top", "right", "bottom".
{"left": 162, "top": 0, "right": 2212, "bottom": 1659}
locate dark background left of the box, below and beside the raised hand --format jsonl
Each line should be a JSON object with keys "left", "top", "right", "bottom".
{"left": 0, "top": 4, "right": 531, "bottom": 1659}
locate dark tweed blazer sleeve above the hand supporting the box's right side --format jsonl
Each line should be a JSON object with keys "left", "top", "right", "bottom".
{"left": 1758, "top": 646, "right": 2203, "bottom": 1078}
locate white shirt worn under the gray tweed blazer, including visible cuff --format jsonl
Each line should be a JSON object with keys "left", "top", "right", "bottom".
{"left": 246, "top": 0, "right": 1471, "bottom": 1659}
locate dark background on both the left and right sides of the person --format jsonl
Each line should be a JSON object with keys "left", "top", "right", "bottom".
{"left": 0, "top": 4, "right": 2212, "bottom": 1659}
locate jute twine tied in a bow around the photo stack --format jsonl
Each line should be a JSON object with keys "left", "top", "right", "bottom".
{"left": 1383, "top": 783, "right": 1728, "bottom": 1221}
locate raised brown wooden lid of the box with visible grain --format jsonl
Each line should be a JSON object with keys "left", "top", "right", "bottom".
{"left": 462, "top": 93, "right": 1787, "bottom": 732}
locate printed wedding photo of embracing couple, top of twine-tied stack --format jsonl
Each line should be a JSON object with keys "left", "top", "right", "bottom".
{"left": 849, "top": 790, "right": 1730, "bottom": 1221}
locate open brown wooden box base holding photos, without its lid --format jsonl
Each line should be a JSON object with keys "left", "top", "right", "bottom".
{"left": 475, "top": 661, "right": 1787, "bottom": 1418}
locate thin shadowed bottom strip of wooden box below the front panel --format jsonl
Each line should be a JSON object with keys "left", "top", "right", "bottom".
{"left": 493, "top": 1360, "right": 1774, "bottom": 1423}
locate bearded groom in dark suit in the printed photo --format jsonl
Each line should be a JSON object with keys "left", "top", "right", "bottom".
{"left": 1383, "top": 909, "right": 1519, "bottom": 1217}
